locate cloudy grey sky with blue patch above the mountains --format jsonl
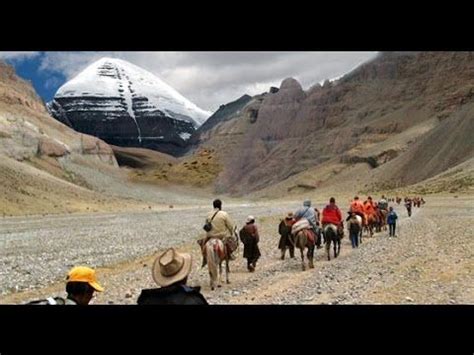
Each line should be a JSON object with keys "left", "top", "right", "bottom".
{"left": 0, "top": 52, "right": 376, "bottom": 111}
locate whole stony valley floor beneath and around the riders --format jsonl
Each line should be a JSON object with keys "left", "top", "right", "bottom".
{"left": 0, "top": 195, "right": 474, "bottom": 304}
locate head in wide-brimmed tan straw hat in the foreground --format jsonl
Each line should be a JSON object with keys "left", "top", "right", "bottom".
{"left": 152, "top": 248, "right": 192, "bottom": 287}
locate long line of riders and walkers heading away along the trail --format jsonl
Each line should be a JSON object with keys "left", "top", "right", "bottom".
{"left": 198, "top": 195, "right": 425, "bottom": 278}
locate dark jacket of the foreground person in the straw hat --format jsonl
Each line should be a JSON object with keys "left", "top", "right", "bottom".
{"left": 137, "top": 284, "right": 209, "bottom": 305}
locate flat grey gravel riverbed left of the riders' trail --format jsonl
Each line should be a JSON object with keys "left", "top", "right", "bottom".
{"left": 0, "top": 204, "right": 300, "bottom": 295}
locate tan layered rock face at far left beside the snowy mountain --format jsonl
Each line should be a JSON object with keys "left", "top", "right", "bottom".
{"left": 0, "top": 62, "right": 117, "bottom": 166}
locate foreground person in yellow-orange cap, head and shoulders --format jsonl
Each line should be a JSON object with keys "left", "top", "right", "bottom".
{"left": 27, "top": 266, "right": 104, "bottom": 306}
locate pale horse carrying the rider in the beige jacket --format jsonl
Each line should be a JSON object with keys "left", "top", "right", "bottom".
{"left": 204, "top": 238, "right": 230, "bottom": 290}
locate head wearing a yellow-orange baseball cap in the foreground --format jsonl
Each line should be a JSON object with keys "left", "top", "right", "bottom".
{"left": 66, "top": 266, "right": 104, "bottom": 305}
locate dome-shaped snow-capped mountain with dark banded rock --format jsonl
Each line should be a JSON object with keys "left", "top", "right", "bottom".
{"left": 48, "top": 58, "right": 211, "bottom": 154}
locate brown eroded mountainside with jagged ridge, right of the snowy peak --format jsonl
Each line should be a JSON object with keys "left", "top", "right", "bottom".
{"left": 192, "top": 52, "right": 474, "bottom": 194}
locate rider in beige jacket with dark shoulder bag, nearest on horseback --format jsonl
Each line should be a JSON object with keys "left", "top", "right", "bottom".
{"left": 198, "top": 199, "right": 236, "bottom": 267}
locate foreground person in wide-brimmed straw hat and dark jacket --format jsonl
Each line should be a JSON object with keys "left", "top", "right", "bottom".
{"left": 137, "top": 248, "right": 208, "bottom": 305}
